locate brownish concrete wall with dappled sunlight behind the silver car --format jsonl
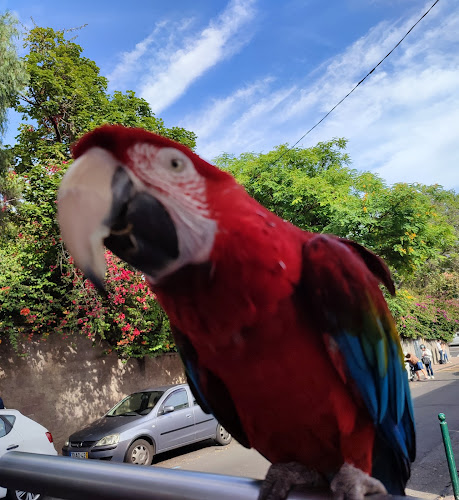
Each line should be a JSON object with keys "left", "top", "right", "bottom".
{"left": 0, "top": 335, "right": 185, "bottom": 452}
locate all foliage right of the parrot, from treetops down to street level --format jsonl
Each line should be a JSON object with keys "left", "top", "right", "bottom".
{"left": 216, "top": 143, "right": 459, "bottom": 340}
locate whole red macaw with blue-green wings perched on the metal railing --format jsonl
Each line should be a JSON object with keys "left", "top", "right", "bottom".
{"left": 59, "top": 126, "right": 415, "bottom": 499}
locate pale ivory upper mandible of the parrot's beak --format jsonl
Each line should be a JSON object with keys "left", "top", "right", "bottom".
{"left": 58, "top": 148, "right": 117, "bottom": 290}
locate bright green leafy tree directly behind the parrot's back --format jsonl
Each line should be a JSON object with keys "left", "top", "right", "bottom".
{"left": 216, "top": 139, "right": 457, "bottom": 279}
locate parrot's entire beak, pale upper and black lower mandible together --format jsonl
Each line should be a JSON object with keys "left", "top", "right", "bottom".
{"left": 58, "top": 148, "right": 178, "bottom": 290}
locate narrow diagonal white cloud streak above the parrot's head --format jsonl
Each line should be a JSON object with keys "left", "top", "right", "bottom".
{"left": 140, "top": 0, "right": 255, "bottom": 113}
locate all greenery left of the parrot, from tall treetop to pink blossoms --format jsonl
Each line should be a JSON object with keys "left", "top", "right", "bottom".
{"left": 0, "top": 27, "right": 195, "bottom": 357}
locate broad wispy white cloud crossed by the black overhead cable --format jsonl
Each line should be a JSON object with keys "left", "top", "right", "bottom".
{"left": 181, "top": 4, "right": 459, "bottom": 189}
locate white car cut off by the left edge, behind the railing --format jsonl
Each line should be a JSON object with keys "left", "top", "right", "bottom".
{"left": 0, "top": 409, "right": 57, "bottom": 500}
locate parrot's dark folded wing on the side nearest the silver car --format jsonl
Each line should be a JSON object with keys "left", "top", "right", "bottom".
{"left": 172, "top": 326, "right": 250, "bottom": 448}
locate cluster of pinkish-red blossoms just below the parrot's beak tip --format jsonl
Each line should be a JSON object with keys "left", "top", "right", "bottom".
{"left": 63, "top": 251, "right": 175, "bottom": 358}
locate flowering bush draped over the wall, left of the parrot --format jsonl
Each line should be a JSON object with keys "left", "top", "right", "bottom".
{"left": 0, "top": 160, "right": 175, "bottom": 359}
